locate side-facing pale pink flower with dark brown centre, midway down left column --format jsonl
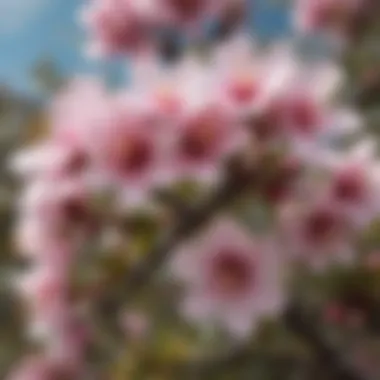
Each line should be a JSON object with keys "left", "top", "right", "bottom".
{"left": 16, "top": 181, "right": 95, "bottom": 265}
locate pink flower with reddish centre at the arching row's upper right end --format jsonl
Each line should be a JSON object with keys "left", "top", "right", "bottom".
{"left": 250, "top": 62, "right": 362, "bottom": 157}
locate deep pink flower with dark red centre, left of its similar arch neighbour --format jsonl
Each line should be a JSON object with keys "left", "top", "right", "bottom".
{"left": 89, "top": 97, "right": 166, "bottom": 205}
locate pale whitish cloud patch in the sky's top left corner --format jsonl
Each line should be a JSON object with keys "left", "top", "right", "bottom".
{"left": 0, "top": 0, "right": 52, "bottom": 34}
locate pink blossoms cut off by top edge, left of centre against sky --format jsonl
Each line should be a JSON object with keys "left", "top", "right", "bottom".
{"left": 80, "top": 0, "right": 246, "bottom": 56}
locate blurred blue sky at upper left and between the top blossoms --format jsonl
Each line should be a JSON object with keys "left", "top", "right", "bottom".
{"left": 0, "top": 0, "right": 287, "bottom": 95}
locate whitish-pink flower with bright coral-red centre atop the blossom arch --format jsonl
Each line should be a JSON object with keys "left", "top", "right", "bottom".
{"left": 211, "top": 34, "right": 295, "bottom": 116}
